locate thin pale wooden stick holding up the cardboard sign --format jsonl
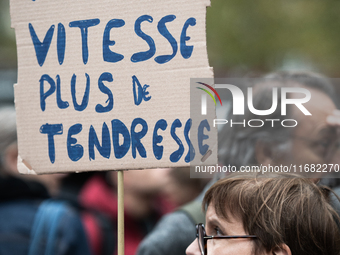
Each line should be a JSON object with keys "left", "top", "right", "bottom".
{"left": 117, "top": 170, "right": 124, "bottom": 255}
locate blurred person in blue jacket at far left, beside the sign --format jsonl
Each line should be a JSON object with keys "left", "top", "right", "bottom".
{"left": 0, "top": 106, "right": 91, "bottom": 255}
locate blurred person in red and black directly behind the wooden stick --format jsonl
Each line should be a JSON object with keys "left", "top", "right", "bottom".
{"left": 58, "top": 168, "right": 174, "bottom": 255}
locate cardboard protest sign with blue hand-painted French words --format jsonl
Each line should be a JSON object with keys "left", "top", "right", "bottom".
{"left": 10, "top": 0, "right": 217, "bottom": 174}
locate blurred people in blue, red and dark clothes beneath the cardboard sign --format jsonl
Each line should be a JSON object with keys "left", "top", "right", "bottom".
{"left": 0, "top": 103, "right": 207, "bottom": 255}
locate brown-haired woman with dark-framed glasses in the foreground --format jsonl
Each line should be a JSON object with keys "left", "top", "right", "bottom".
{"left": 186, "top": 175, "right": 340, "bottom": 255}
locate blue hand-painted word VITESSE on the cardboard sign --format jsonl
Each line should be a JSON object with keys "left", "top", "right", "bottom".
{"left": 28, "top": 15, "right": 196, "bottom": 66}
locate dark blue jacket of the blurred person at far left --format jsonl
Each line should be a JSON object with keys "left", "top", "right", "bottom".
{"left": 0, "top": 177, "right": 90, "bottom": 255}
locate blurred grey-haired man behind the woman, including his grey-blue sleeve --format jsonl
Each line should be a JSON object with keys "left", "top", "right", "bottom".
{"left": 137, "top": 71, "right": 340, "bottom": 255}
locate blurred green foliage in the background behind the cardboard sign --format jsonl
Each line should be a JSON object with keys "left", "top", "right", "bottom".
{"left": 0, "top": 0, "right": 340, "bottom": 78}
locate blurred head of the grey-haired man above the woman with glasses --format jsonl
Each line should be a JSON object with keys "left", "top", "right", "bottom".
{"left": 219, "top": 71, "right": 340, "bottom": 176}
